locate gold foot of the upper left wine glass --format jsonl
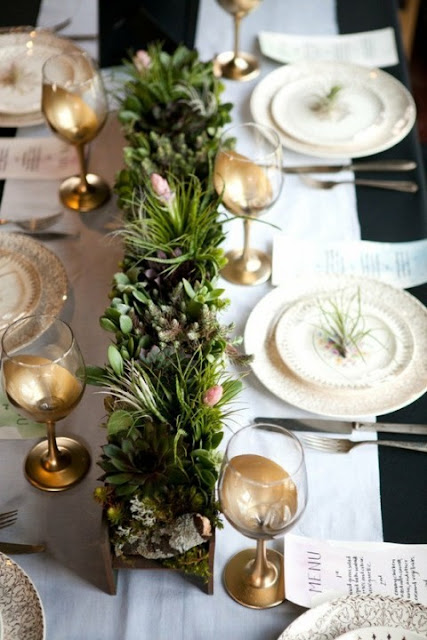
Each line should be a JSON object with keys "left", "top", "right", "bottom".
{"left": 59, "top": 173, "right": 111, "bottom": 212}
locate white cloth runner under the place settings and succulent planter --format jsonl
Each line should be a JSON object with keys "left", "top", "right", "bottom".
{"left": 0, "top": 0, "right": 388, "bottom": 640}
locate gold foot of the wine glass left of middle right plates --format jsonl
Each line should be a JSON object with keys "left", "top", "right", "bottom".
{"left": 221, "top": 249, "right": 271, "bottom": 286}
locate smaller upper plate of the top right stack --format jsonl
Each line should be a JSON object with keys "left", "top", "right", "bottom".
{"left": 271, "top": 74, "right": 386, "bottom": 146}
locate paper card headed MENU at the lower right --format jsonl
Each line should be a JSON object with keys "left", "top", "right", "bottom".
{"left": 285, "top": 534, "right": 427, "bottom": 607}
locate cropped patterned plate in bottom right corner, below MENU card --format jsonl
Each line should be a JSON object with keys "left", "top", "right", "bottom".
{"left": 278, "top": 595, "right": 427, "bottom": 640}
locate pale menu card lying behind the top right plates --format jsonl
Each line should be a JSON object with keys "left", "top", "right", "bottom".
{"left": 259, "top": 27, "right": 399, "bottom": 67}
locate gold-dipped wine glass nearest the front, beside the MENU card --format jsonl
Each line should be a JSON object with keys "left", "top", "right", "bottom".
{"left": 219, "top": 423, "right": 307, "bottom": 609}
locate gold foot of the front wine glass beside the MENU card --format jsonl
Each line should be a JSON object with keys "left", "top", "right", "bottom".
{"left": 224, "top": 549, "right": 285, "bottom": 609}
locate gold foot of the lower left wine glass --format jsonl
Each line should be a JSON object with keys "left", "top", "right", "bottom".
{"left": 25, "top": 436, "right": 90, "bottom": 491}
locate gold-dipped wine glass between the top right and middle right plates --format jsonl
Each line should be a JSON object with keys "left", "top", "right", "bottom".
{"left": 213, "top": 122, "right": 283, "bottom": 285}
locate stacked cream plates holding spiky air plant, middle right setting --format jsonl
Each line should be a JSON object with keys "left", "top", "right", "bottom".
{"left": 244, "top": 275, "right": 427, "bottom": 417}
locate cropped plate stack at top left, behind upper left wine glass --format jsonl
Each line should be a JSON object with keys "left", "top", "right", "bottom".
{"left": 0, "top": 27, "right": 81, "bottom": 127}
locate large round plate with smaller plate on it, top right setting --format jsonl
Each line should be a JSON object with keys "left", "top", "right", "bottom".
{"left": 250, "top": 61, "right": 416, "bottom": 158}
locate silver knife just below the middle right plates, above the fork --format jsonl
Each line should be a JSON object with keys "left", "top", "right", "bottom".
{"left": 255, "top": 418, "right": 427, "bottom": 436}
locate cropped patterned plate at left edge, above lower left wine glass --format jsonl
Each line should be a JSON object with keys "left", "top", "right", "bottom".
{"left": 0, "top": 232, "right": 68, "bottom": 344}
